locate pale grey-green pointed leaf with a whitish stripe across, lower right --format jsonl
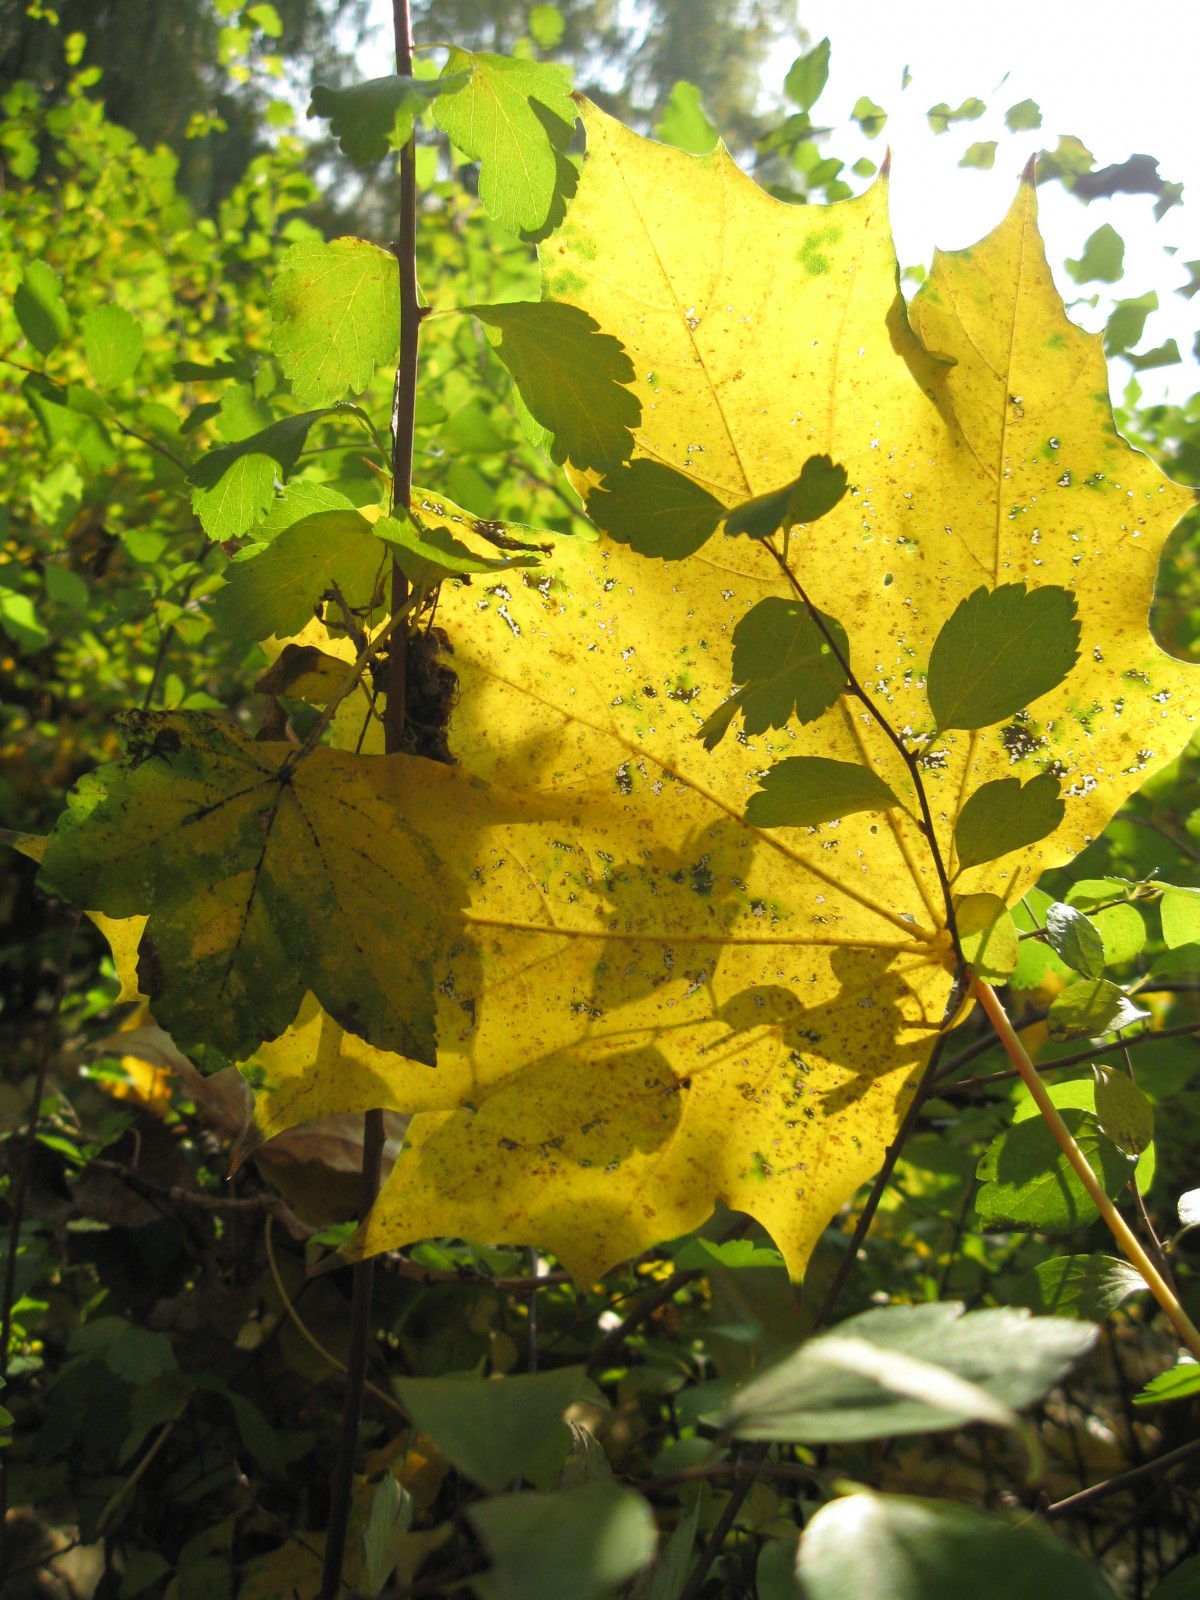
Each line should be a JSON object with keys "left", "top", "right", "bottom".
{"left": 722, "top": 1301, "right": 1096, "bottom": 1443}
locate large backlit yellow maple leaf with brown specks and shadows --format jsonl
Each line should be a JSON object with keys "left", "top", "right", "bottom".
{"left": 246, "top": 107, "right": 1195, "bottom": 1278}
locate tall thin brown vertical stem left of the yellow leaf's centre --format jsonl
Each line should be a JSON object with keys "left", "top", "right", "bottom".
{"left": 320, "top": 9, "right": 421, "bottom": 1600}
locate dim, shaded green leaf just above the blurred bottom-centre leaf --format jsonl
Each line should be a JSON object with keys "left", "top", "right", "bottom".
{"left": 392, "top": 1366, "right": 602, "bottom": 1494}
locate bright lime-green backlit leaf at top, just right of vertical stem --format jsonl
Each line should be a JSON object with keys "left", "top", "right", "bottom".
{"left": 434, "top": 48, "right": 578, "bottom": 234}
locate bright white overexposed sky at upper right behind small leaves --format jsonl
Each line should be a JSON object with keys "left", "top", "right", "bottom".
{"left": 362, "top": 0, "right": 1200, "bottom": 400}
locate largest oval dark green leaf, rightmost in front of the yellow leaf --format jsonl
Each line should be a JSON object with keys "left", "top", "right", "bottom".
{"left": 925, "top": 584, "right": 1080, "bottom": 733}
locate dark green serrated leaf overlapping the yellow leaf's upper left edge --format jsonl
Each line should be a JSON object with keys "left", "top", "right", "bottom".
{"left": 464, "top": 301, "right": 642, "bottom": 472}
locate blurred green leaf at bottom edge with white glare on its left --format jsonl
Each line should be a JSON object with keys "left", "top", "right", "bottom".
{"left": 797, "top": 1493, "right": 1117, "bottom": 1600}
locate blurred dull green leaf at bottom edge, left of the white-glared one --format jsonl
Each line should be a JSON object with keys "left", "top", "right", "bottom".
{"left": 467, "top": 1472, "right": 656, "bottom": 1600}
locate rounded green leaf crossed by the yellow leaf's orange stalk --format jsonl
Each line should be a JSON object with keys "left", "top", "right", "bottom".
{"left": 974, "top": 1109, "right": 1138, "bottom": 1234}
